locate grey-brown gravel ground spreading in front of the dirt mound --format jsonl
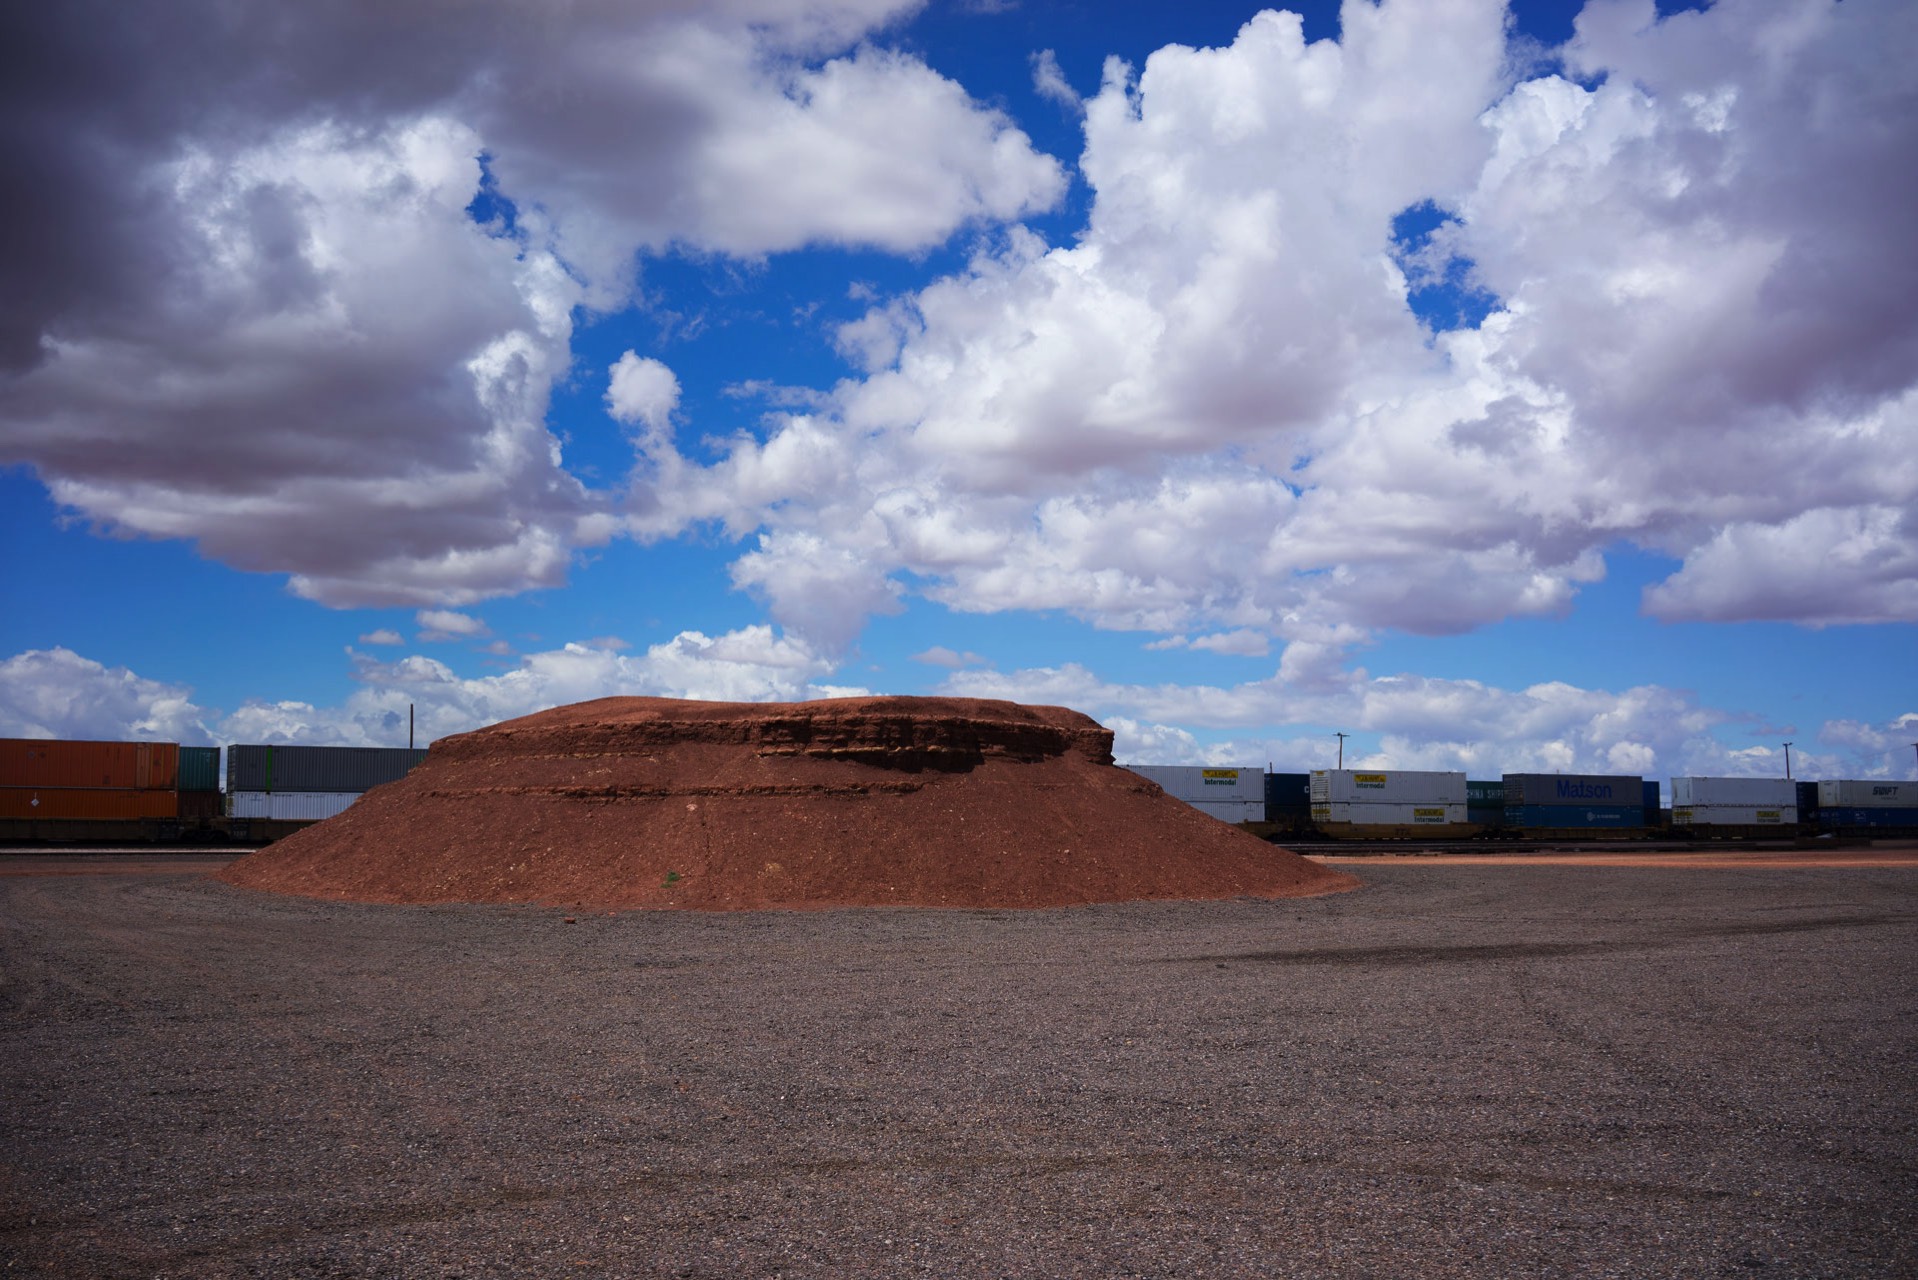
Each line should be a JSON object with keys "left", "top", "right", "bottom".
{"left": 0, "top": 865, "right": 1918, "bottom": 1278}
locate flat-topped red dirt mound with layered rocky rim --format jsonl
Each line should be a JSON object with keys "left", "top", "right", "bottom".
{"left": 221, "top": 699, "right": 1358, "bottom": 910}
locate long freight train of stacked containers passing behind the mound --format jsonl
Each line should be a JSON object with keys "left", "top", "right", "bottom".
{"left": 0, "top": 739, "right": 1918, "bottom": 844}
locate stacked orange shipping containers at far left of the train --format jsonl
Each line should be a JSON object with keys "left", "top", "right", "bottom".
{"left": 0, "top": 737, "right": 180, "bottom": 823}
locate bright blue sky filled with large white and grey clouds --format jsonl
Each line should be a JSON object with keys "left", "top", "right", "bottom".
{"left": 0, "top": 0, "right": 1918, "bottom": 777}
